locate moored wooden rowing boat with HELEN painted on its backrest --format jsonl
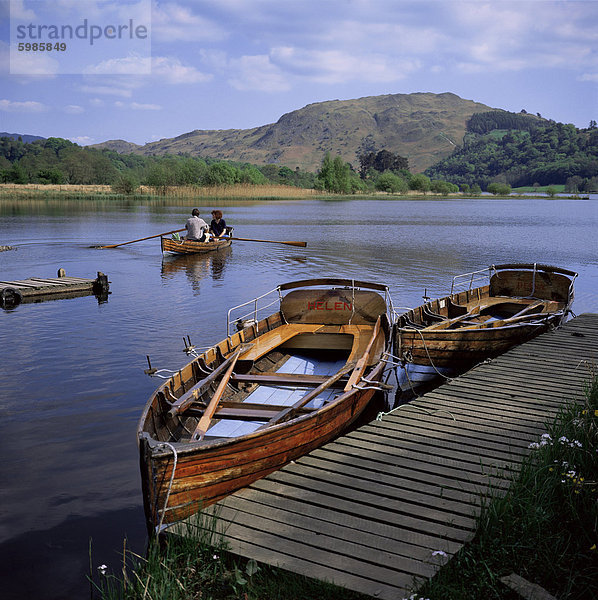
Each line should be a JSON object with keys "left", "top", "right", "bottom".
{"left": 137, "top": 279, "right": 392, "bottom": 532}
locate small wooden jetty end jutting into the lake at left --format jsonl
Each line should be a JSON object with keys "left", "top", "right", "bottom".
{"left": 0, "top": 269, "right": 109, "bottom": 308}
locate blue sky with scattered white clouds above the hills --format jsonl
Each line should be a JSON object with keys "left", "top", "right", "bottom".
{"left": 0, "top": 0, "right": 598, "bottom": 145}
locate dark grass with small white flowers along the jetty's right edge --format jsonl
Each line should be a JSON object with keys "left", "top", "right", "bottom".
{"left": 415, "top": 375, "right": 598, "bottom": 600}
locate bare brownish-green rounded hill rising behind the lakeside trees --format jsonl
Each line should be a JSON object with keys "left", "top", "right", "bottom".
{"left": 92, "top": 93, "right": 493, "bottom": 172}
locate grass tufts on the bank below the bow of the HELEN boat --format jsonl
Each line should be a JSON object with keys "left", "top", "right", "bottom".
{"left": 89, "top": 513, "right": 367, "bottom": 600}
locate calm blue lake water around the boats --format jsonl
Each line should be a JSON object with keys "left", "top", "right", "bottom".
{"left": 0, "top": 197, "right": 598, "bottom": 600}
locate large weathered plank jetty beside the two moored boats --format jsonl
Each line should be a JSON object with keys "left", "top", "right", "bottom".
{"left": 191, "top": 314, "right": 598, "bottom": 600}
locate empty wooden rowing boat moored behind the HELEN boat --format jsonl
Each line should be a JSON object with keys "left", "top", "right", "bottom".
{"left": 393, "top": 264, "right": 577, "bottom": 390}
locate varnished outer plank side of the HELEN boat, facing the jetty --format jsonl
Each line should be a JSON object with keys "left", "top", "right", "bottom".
{"left": 140, "top": 366, "right": 382, "bottom": 524}
